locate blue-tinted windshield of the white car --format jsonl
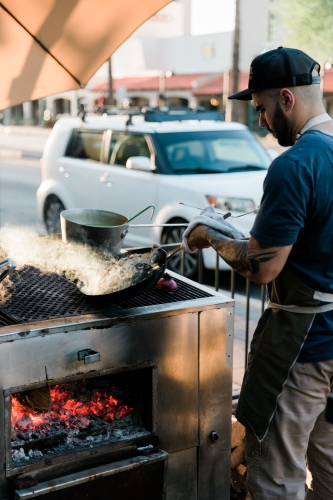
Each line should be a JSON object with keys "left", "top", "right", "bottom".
{"left": 155, "top": 130, "right": 270, "bottom": 174}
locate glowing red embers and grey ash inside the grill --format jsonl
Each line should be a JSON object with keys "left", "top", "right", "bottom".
{"left": 11, "top": 379, "right": 147, "bottom": 462}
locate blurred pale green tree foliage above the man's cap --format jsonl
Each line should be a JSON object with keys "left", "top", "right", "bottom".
{"left": 275, "top": 0, "right": 333, "bottom": 65}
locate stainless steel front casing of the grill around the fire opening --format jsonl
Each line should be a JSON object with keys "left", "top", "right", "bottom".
{"left": 0, "top": 275, "right": 233, "bottom": 500}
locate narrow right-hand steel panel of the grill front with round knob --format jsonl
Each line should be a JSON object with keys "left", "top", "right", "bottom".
{"left": 198, "top": 308, "right": 232, "bottom": 500}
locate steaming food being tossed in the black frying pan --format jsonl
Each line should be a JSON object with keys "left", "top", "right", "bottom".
{"left": 0, "top": 227, "right": 164, "bottom": 303}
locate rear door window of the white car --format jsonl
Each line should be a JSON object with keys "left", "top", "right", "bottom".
{"left": 67, "top": 130, "right": 103, "bottom": 161}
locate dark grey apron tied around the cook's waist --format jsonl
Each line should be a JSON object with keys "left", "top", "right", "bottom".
{"left": 236, "top": 266, "right": 333, "bottom": 441}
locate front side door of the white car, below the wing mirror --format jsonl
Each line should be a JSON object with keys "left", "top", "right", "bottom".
{"left": 100, "top": 131, "right": 159, "bottom": 246}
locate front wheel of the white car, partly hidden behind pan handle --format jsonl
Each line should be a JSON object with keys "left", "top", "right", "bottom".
{"left": 161, "top": 218, "right": 198, "bottom": 279}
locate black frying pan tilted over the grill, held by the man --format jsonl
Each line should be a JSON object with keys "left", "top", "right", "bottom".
{"left": 80, "top": 245, "right": 181, "bottom": 301}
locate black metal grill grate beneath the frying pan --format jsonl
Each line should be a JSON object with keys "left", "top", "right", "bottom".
{"left": 0, "top": 267, "right": 211, "bottom": 326}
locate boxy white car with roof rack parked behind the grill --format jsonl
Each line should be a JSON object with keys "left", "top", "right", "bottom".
{"left": 37, "top": 111, "right": 270, "bottom": 277}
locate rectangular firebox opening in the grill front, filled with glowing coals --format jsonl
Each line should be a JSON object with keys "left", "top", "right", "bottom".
{"left": 7, "top": 369, "right": 154, "bottom": 472}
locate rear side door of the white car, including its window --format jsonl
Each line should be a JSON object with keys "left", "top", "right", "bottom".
{"left": 58, "top": 129, "right": 105, "bottom": 209}
